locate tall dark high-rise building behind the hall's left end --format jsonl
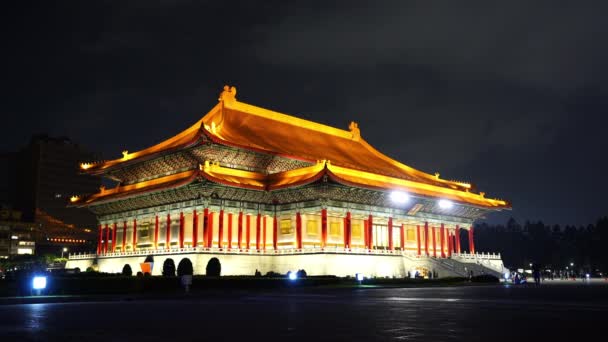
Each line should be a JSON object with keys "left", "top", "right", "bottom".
{"left": 0, "top": 134, "right": 100, "bottom": 253}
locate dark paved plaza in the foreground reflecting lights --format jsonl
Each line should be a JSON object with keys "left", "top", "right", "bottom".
{"left": 0, "top": 281, "right": 608, "bottom": 342}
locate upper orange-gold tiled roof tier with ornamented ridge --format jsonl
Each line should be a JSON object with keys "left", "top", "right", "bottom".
{"left": 81, "top": 86, "right": 471, "bottom": 191}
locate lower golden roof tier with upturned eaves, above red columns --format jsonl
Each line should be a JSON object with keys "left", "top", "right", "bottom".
{"left": 70, "top": 161, "right": 511, "bottom": 210}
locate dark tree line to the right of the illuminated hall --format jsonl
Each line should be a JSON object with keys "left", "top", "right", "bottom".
{"left": 476, "top": 217, "right": 608, "bottom": 274}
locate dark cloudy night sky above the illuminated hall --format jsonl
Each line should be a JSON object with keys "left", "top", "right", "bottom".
{"left": 0, "top": 0, "right": 608, "bottom": 225}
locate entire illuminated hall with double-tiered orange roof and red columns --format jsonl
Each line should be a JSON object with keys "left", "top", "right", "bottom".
{"left": 68, "top": 87, "right": 510, "bottom": 276}
